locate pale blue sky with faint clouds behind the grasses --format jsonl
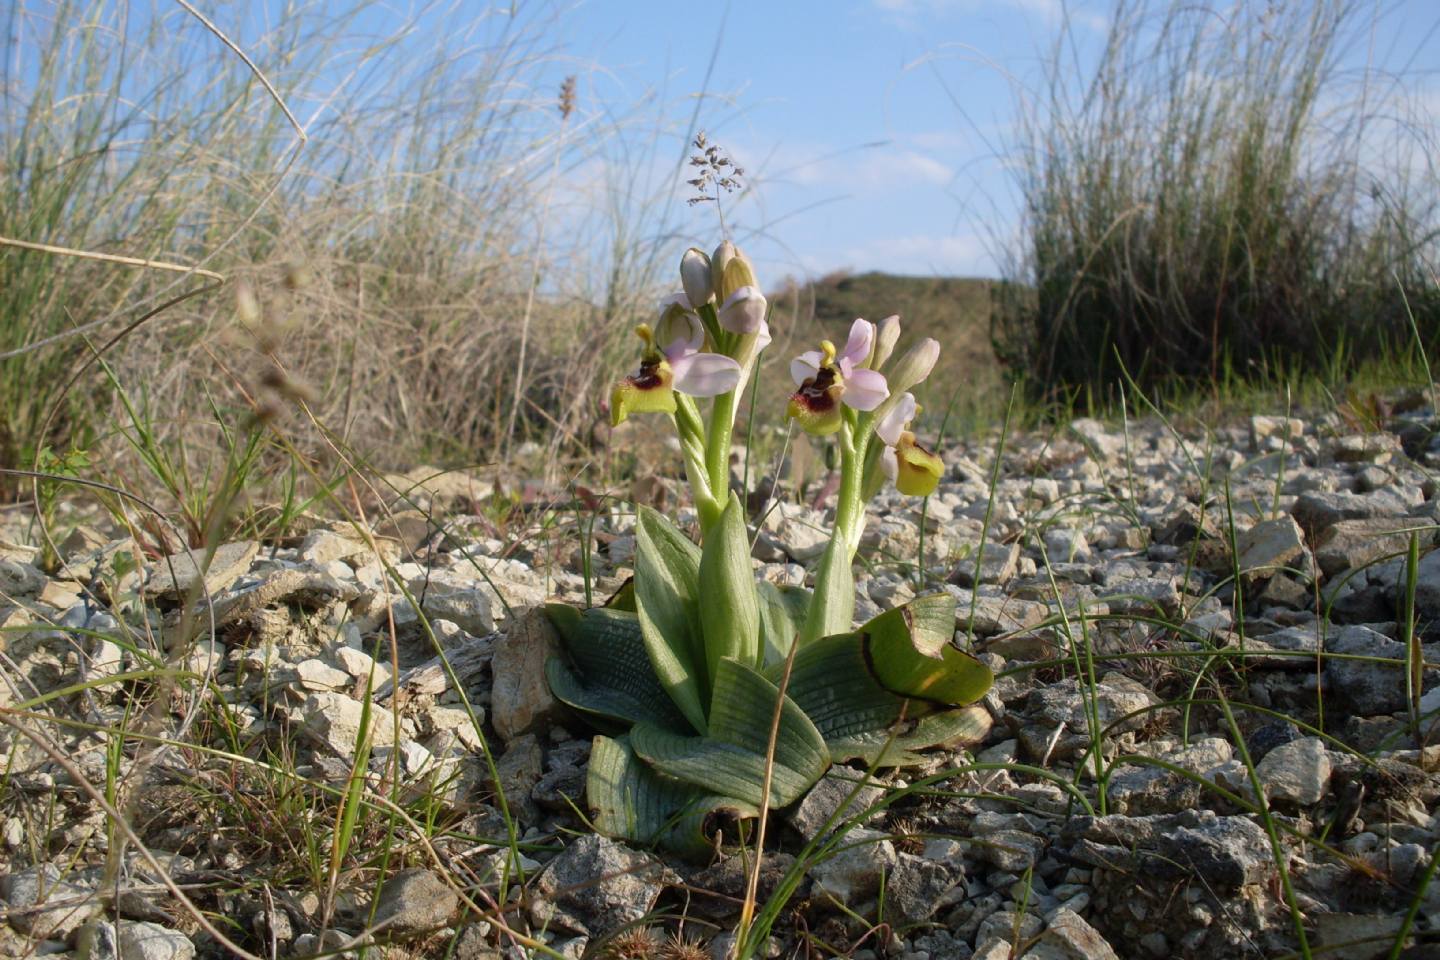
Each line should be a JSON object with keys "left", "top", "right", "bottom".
{"left": 11, "top": 0, "right": 1440, "bottom": 288}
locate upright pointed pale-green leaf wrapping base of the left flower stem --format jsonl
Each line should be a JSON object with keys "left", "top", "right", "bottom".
{"left": 700, "top": 492, "right": 760, "bottom": 676}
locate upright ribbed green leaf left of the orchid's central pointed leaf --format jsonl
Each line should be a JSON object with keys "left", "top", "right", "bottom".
{"left": 635, "top": 507, "right": 710, "bottom": 733}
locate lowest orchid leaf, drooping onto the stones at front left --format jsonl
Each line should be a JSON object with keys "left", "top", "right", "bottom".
{"left": 585, "top": 737, "right": 760, "bottom": 856}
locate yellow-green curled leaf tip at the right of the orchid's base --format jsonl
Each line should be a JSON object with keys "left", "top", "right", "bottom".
{"left": 860, "top": 593, "right": 995, "bottom": 705}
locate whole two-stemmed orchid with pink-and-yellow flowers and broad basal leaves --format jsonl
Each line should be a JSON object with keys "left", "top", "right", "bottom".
{"left": 547, "top": 242, "right": 994, "bottom": 853}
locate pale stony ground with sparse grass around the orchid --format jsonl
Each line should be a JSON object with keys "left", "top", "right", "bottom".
{"left": 0, "top": 402, "right": 1440, "bottom": 960}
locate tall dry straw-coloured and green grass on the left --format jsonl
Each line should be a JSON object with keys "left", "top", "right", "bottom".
{"left": 0, "top": 0, "right": 684, "bottom": 495}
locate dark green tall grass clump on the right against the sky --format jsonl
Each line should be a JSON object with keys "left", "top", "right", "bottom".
{"left": 994, "top": 0, "right": 1440, "bottom": 403}
